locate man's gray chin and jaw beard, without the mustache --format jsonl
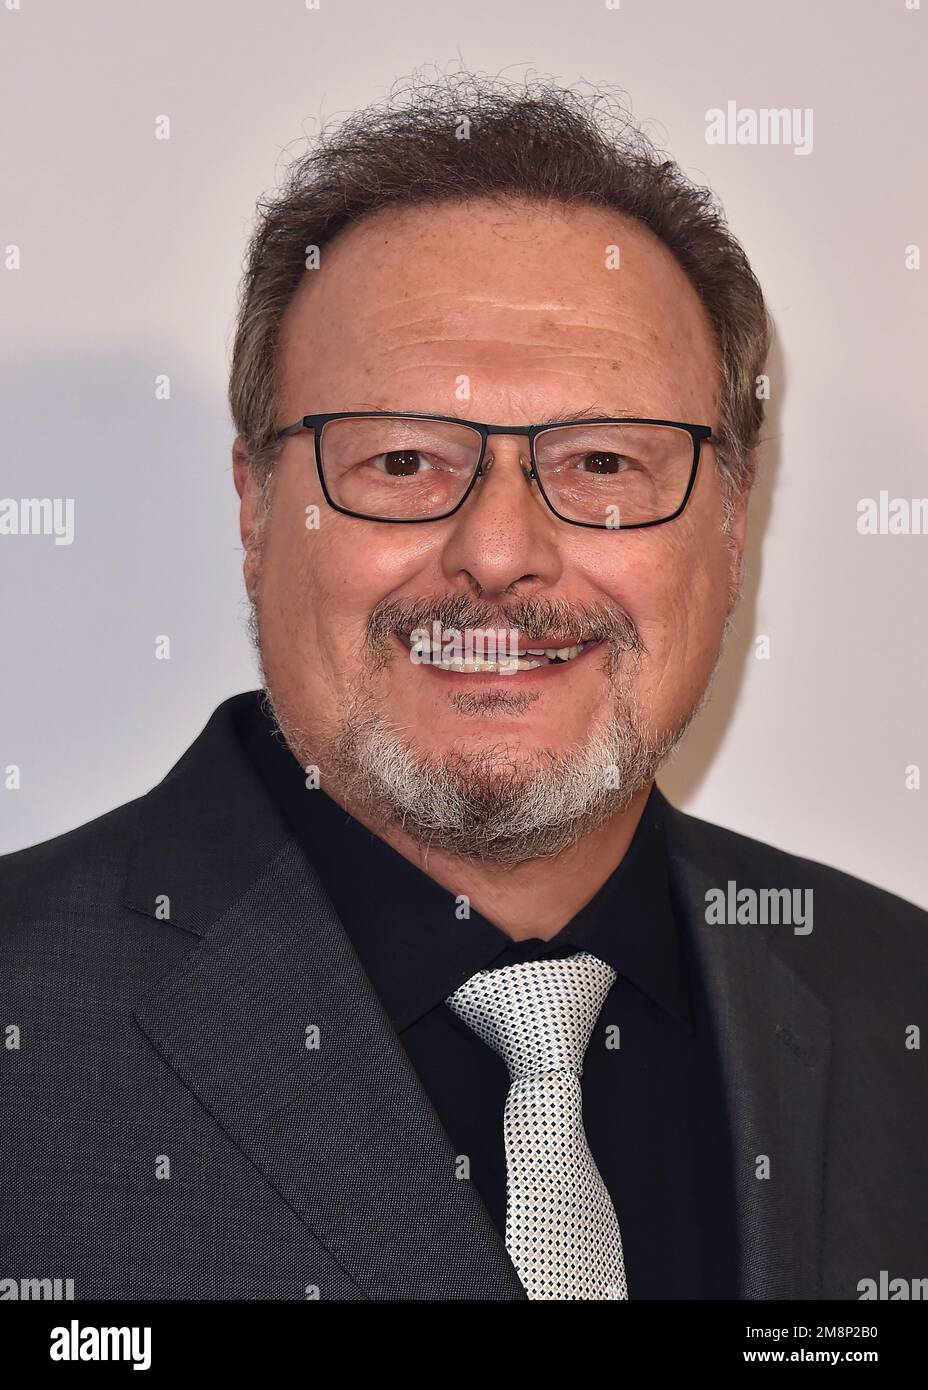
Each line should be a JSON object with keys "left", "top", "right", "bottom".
{"left": 253, "top": 621, "right": 711, "bottom": 867}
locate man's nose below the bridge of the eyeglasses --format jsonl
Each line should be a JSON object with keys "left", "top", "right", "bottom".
{"left": 442, "top": 435, "right": 563, "bottom": 598}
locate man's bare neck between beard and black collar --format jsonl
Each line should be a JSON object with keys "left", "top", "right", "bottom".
{"left": 329, "top": 783, "right": 653, "bottom": 941}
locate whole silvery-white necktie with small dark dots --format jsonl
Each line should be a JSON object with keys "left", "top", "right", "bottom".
{"left": 446, "top": 951, "right": 628, "bottom": 1300}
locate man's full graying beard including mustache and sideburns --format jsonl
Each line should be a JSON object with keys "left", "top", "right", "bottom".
{"left": 249, "top": 497, "right": 740, "bottom": 867}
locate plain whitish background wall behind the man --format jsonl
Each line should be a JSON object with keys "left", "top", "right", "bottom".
{"left": 0, "top": 0, "right": 928, "bottom": 906}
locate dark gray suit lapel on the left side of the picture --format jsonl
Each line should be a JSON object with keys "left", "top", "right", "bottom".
{"left": 128, "top": 702, "right": 525, "bottom": 1300}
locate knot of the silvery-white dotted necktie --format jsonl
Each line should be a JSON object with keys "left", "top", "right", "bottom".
{"left": 446, "top": 951, "right": 615, "bottom": 1080}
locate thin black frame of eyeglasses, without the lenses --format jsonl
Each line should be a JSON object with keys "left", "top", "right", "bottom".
{"left": 275, "top": 410, "right": 713, "bottom": 531}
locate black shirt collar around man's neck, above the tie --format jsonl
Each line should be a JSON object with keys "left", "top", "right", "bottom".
{"left": 239, "top": 691, "right": 692, "bottom": 1031}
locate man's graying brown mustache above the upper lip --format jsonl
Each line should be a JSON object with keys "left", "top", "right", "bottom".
{"left": 367, "top": 594, "right": 645, "bottom": 659}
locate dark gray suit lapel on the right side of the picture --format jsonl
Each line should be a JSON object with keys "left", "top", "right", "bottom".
{"left": 664, "top": 802, "right": 831, "bottom": 1300}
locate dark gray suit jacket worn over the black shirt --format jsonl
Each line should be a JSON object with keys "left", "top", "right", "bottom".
{"left": 0, "top": 696, "right": 928, "bottom": 1300}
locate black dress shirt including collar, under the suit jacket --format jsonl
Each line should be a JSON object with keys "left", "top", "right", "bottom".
{"left": 239, "top": 696, "right": 736, "bottom": 1300}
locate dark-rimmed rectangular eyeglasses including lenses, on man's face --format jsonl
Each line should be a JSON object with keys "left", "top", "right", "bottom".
{"left": 276, "top": 410, "right": 713, "bottom": 531}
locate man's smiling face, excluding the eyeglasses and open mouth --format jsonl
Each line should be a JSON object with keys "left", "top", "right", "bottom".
{"left": 236, "top": 200, "right": 743, "bottom": 852}
